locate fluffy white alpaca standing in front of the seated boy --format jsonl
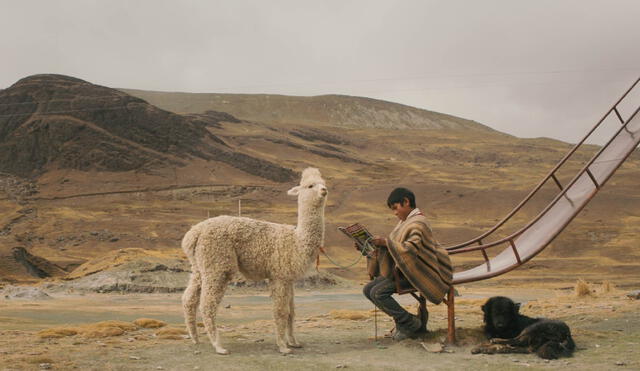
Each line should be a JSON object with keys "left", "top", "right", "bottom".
{"left": 182, "top": 168, "right": 327, "bottom": 354}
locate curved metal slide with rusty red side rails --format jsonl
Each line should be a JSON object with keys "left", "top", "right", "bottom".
{"left": 446, "top": 79, "right": 640, "bottom": 285}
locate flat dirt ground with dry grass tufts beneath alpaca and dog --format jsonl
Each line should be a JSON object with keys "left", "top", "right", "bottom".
{"left": 0, "top": 283, "right": 640, "bottom": 371}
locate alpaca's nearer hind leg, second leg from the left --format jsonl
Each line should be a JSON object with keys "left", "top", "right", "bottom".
{"left": 200, "top": 271, "right": 231, "bottom": 354}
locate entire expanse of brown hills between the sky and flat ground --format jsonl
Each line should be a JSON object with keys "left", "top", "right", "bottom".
{"left": 0, "top": 75, "right": 640, "bottom": 285}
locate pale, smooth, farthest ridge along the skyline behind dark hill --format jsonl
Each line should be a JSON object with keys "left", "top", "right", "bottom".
{"left": 120, "top": 89, "right": 506, "bottom": 135}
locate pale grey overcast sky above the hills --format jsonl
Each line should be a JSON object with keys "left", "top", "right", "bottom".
{"left": 0, "top": 0, "right": 640, "bottom": 142}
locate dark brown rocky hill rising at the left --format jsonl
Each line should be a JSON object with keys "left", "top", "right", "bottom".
{"left": 0, "top": 74, "right": 294, "bottom": 181}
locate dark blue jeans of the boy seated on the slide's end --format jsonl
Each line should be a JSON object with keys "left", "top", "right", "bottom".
{"left": 362, "top": 276, "right": 420, "bottom": 332}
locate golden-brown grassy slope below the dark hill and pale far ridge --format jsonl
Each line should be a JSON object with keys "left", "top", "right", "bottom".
{"left": 0, "top": 74, "right": 640, "bottom": 284}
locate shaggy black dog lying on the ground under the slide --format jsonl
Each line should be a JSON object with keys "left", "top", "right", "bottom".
{"left": 471, "top": 296, "right": 576, "bottom": 359}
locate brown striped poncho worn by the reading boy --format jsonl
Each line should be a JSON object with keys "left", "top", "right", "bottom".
{"left": 367, "top": 210, "right": 453, "bottom": 304}
